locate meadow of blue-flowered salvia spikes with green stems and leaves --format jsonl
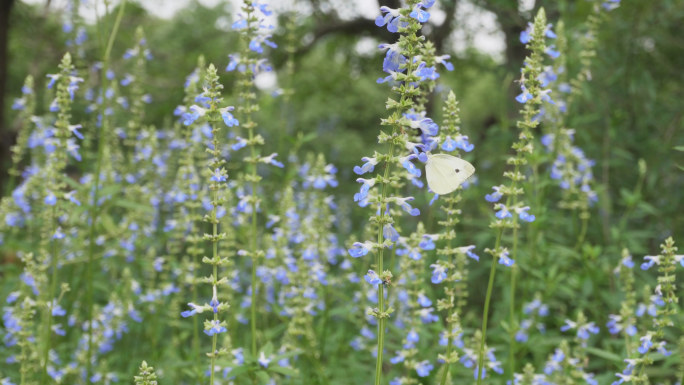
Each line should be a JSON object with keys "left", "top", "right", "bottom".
{"left": 0, "top": 0, "right": 684, "bottom": 385}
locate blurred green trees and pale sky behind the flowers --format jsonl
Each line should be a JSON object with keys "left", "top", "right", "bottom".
{"left": 0, "top": 0, "right": 684, "bottom": 250}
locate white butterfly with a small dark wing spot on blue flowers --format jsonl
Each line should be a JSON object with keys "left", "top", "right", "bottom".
{"left": 425, "top": 154, "right": 475, "bottom": 195}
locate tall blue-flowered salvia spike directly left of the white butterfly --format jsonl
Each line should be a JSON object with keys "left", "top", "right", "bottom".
{"left": 349, "top": 0, "right": 454, "bottom": 385}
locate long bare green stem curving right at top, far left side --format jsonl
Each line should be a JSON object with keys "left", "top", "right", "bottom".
{"left": 86, "top": 0, "right": 126, "bottom": 378}
